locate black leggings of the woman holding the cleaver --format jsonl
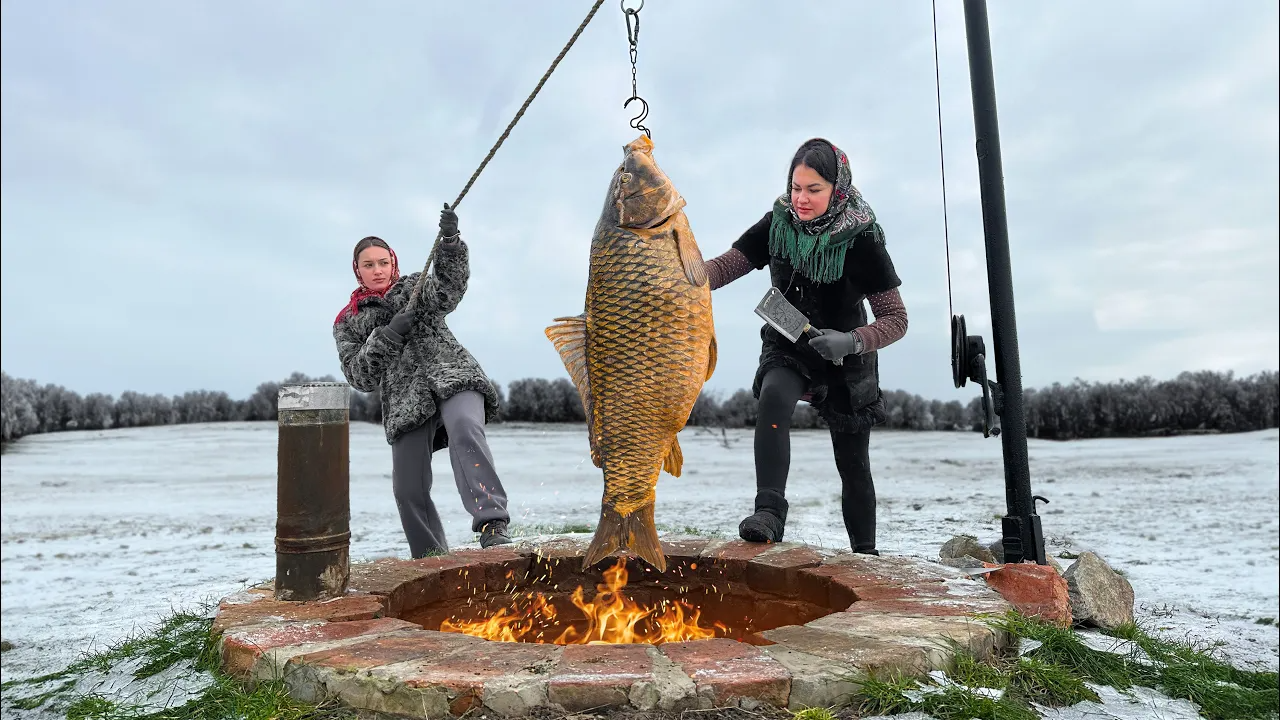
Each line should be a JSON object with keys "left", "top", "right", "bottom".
{"left": 755, "top": 368, "right": 876, "bottom": 551}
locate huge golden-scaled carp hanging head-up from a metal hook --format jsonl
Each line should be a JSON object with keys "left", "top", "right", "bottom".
{"left": 547, "top": 136, "right": 716, "bottom": 571}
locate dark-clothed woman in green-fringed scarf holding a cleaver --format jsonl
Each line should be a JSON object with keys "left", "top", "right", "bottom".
{"left": 707, "top": 138, "right": 906, "bottom": 555}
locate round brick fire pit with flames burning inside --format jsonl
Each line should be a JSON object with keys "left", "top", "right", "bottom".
{"left": 214, "top": 538, "right": 1009, "bottom": 717}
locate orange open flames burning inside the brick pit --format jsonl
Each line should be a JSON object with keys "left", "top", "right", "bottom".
{"left": 440, "top": 557, "right": 730, "bottom": 644}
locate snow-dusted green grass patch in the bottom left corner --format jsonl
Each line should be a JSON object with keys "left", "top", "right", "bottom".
{"left": 0, "top": 599, "right": 356, "bottom": 720}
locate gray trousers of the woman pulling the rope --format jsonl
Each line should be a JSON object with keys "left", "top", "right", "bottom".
{"left": 392, "top": 391, "right": 511, "bottom": 559}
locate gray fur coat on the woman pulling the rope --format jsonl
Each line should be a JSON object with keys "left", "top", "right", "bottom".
{"left": 333, "top": 240, "right": 498, "bottom": 450}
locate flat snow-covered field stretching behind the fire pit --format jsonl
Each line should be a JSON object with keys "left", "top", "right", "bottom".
{"left": 0, "top": 423, "right": 1280, "bottom": 680}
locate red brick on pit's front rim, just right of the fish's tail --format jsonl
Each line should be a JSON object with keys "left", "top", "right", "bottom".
{"left": 659, "top": 638, "right": 791, "bottom": 707}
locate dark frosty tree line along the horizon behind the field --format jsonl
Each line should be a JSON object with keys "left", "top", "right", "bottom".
{"left": 0, "top": 370, "right": 1280, "bottom": 442}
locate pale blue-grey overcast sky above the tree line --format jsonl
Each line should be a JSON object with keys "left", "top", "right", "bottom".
{"left": 0, "top": 0, "right": 1280, "bottom": 400}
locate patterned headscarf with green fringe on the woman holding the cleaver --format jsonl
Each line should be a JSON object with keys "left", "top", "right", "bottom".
{"left": 769, "top": 137, "right": 876, "bottom": 283}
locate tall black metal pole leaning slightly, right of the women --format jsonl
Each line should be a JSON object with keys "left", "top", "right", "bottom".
{"left": 964, "top": 0, "right": 1046, "bottom": 565}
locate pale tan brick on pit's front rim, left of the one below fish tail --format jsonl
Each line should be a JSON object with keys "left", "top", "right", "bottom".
{"left": 399, "top": 642, "right": 561, "bottom": 715}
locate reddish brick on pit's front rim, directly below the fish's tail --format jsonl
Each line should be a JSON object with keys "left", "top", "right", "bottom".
{"left": 547, "top": 644, "right": 654, "bottom": 712}
